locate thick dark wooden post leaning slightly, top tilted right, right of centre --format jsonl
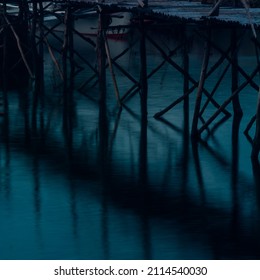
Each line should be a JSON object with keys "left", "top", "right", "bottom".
{"left": 191, "top": 27, "right": 211, "bottom": 139}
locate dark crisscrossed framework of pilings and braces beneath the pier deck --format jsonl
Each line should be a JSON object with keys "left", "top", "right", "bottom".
{"left": 0, "top": 0, "right": 260, "bottom": 158}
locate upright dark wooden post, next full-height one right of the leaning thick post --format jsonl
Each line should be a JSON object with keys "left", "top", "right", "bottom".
{"left": 231, "top": 27, "right": 243, "bottom": 116}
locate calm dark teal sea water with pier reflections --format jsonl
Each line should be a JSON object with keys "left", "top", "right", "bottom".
{"left": 0, "top": 25, "right": 260, "bottom": 259}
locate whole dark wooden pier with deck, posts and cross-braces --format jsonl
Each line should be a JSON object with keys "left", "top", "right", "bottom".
{"left": 0, "top": 0, "right": 260, "bottom": 160}
